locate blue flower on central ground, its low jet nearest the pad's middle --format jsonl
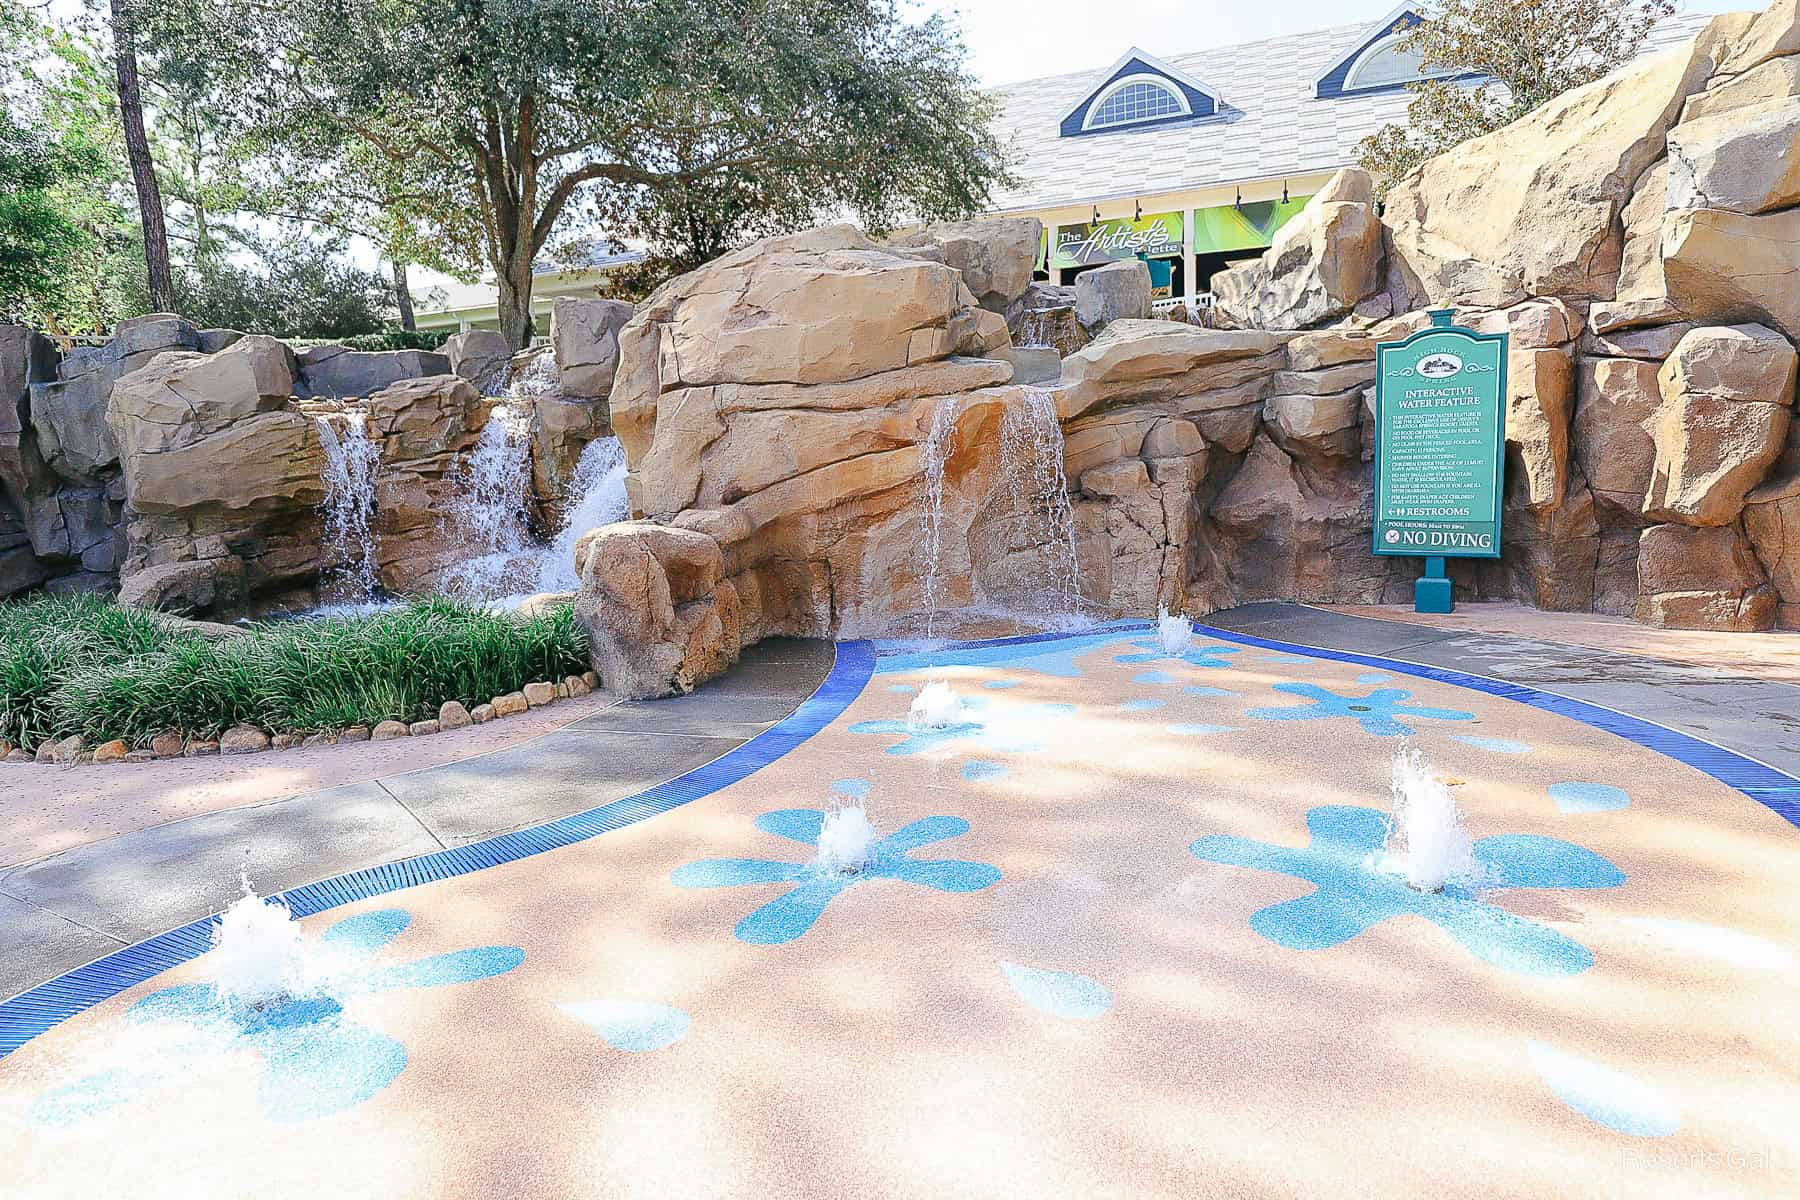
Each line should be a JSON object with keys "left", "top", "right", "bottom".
{"left": 671, "top": 808, "right": 1001, "bottom": 946}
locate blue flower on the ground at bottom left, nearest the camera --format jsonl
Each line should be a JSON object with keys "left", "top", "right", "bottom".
{"left": 32, "top": 909, "right": 526, "bottom": 1126}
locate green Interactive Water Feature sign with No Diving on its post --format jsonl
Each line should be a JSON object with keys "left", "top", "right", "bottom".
{"left": 1373, "top": 308, "right": 1507, "bottom": 612}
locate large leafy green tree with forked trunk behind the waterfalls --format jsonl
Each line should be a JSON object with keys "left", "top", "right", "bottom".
{"left": 146, "top": 0, "right": 1004, "bottom": 345}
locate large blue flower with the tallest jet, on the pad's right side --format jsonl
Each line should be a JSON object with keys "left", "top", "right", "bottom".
{"left": 1188, "top": 804, "right": 1625, "bottom": 975}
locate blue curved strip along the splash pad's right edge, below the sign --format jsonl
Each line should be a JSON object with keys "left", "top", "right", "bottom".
{"left": 1195, "top": 624, "right": 1800, "bottom": 828}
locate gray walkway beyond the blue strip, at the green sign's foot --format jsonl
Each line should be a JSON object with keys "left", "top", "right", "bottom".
{"left": 1206, "top": 603, "right": 1800, "bottom": 775}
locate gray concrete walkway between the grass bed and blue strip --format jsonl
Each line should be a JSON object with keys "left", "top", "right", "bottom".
{"left": 0, "top": 639, "right": 833, "bottom": 999}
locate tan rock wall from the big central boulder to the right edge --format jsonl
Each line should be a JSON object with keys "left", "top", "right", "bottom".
{"left": 585, "top": 0, "right": 1800, "bottom": 689}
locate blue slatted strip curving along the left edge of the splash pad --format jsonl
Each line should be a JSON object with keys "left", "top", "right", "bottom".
{"left": 0, "top": 640, "right": 875, "bottom": 1060}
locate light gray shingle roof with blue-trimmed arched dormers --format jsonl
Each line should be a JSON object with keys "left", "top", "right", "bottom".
{"left": 992, "top": 16, "right": 1710, "bottom": 212}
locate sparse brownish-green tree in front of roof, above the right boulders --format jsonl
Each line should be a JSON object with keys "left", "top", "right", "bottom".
{"left": 1357, "top": 0, "right": 1674, "bottom": 193}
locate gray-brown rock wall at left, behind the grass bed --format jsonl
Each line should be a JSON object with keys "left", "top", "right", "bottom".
{"left": 0, "top": 300, "right": 630, "bottom": 617}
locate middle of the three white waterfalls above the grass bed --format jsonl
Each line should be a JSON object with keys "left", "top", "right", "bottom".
{"left": 445, "top": 405, "right": 535, "bottom": 601}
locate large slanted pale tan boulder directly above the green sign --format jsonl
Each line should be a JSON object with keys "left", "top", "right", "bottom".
{"left": 1384, "top": 43, "right": 1712, "bottom": 308}
